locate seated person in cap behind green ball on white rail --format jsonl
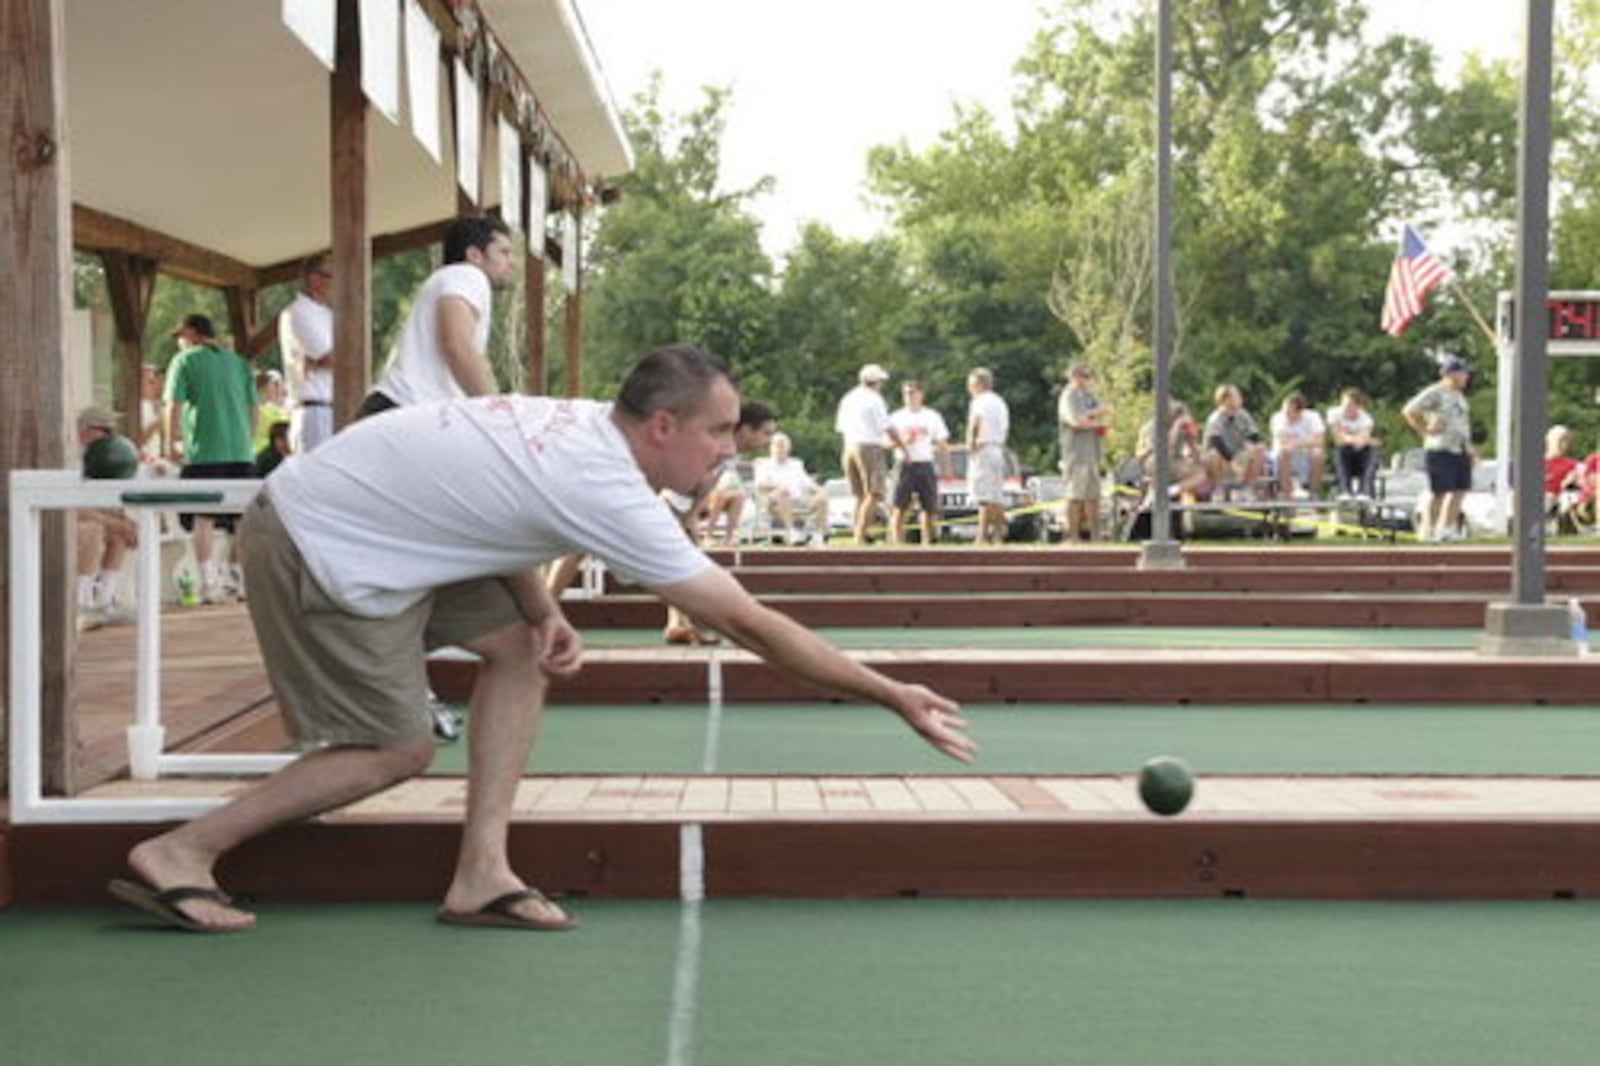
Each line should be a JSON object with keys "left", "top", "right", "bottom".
{"left": 77, "top": 407, "right": 139, "bottom": 629}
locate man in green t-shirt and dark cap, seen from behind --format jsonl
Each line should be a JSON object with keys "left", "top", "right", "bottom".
{"left": 165, "top": 315, "right": 256, "bottom": 603}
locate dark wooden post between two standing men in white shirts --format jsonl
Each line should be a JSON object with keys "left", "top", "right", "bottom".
{"left": 328, "top": 0, "right": 373, "bottom": 427}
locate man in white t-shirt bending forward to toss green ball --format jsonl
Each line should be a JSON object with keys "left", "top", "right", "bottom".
{"left": 112, "top": 347, "right": 976, "bottom": 932}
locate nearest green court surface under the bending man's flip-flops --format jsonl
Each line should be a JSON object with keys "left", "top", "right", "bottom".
{"left": 0, "top": 900, "right": 1600, "bottom": 1066}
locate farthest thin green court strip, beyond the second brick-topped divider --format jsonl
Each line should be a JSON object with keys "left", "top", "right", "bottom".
{"left": 582, "top": 624, "right": 1542, "bottom": 650}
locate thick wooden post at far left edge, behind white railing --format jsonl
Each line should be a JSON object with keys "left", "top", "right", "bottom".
{"left": 0, "top": 0, "right": 77, "bottom": 792}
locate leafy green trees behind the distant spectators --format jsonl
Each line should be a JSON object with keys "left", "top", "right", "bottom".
{"left": 589, "top": 0, "right": 1600, "bottom": 472}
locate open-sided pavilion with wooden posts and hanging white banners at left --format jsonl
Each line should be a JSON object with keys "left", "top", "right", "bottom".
{"left": 0, "top": 0, "right": 632, "bottom": 791}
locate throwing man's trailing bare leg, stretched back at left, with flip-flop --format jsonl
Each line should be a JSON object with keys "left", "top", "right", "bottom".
{"left": 128, "top": 736, "right": 434, "bottom": 928}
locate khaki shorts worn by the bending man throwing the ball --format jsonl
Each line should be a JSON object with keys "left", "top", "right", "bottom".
{"left": 242, "top": 491, "right": 522, "bottom": 747}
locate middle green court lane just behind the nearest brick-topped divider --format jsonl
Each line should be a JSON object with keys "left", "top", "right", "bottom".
{"left": 432, "top": 703, "right": 1600, "bottom": 775}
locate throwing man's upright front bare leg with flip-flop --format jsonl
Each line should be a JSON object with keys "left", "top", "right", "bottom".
{"left": 445, "top": 623, "right": 566, "bottom": 922}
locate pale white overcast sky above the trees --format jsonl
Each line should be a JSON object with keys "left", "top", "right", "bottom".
{"left": 576, "top": 0, "right": 1526, "bottom": 254}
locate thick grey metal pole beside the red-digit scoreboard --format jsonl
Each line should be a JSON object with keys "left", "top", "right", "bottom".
{"left": 1501, "top": 0, "right": 1554, "bottom": 605}
